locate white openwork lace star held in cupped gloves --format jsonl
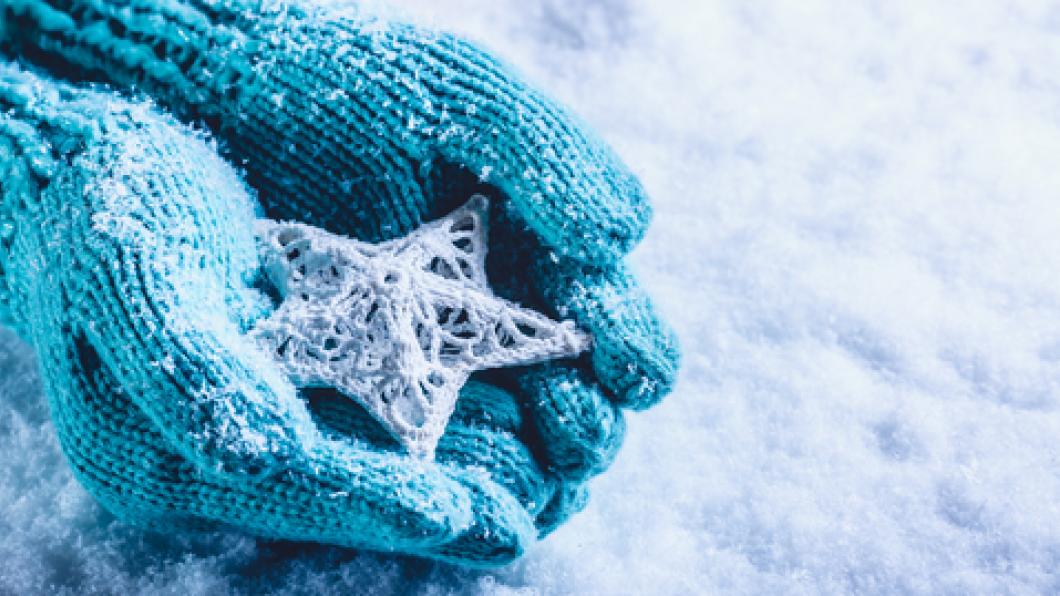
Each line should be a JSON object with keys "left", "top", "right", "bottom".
{"left": 251, "top": 195, "right": 589, "bottom": 458}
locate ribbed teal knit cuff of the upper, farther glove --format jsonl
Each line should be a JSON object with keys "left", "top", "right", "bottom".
{"left": 0, "top": 0, "right": 263, "bottom": 119}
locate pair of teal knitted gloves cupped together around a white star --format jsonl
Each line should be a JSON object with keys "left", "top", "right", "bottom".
{"left": 0, "top": 0, "right": 678, "bottom": 566}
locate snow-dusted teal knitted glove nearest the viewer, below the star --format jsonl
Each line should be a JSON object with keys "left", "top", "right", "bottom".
{"left": 0, "top": 66, "right": 555, "bottom": 565}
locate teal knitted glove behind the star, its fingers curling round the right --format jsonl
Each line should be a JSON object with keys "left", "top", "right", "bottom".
{"left": 0, "top": 0, "right": 677, "bottom": 555}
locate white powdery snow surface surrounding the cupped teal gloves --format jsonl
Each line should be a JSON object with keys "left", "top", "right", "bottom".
{"left": 0, "top": 0, "right": 1060, "bottom": 594}
